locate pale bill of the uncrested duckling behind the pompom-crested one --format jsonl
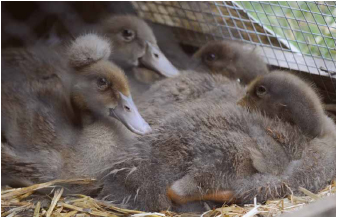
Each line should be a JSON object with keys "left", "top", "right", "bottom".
{"left": 140, "top": 42, "right": 179, "bottom": 77}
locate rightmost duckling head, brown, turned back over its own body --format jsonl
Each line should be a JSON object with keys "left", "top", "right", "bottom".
{"left": 238, "top": 71, "right": 327, "bottom": 137}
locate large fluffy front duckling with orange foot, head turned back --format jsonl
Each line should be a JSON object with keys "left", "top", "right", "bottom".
{"left": 96, "top": 72, "right": 336, "bottom": 211}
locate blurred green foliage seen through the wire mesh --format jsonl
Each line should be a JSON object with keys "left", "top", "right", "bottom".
{"left": 236, "top": 1, "right": 336, "bottom": 59}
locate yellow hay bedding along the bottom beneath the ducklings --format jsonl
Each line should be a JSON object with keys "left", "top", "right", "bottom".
{"left": 1, "top": 179, "right": 336, "bottom": 217}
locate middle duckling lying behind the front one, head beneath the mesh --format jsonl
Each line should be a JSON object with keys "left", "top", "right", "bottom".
{"left": 137, "top": 41, "right": 268, "bottom": 125}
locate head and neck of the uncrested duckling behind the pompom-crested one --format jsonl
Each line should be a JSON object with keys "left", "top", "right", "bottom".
{"left": 34, "top": 15, "right": 182, "bottom": 98}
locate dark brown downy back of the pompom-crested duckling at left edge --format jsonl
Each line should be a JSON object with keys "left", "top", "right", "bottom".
{"left": 1, "top": 48, "right": 77, "bottom": 185}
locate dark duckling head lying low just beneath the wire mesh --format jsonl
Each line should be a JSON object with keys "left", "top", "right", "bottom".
{"left": 193, "top": 41, "right": 268, "bottom": 84}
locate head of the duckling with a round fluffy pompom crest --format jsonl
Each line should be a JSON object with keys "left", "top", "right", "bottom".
{"left": 3, "top": 34, "right": 149, "bottom": 138}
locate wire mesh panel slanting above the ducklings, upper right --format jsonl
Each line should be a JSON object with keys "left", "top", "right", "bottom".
{"left": 132, "top": 1, "right": 336, "bottom": 99}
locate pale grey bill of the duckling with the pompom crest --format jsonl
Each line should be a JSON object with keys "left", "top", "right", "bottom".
{"left": 109, "top": 93, "right": 151, "bottom": 135}
